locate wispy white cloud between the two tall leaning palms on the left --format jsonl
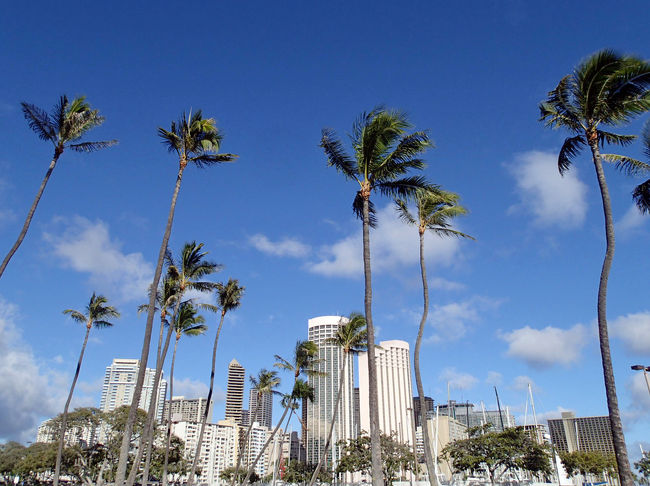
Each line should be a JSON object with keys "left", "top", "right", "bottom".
{"left": 43, "top": 216, "right": 153, "bottom": 301}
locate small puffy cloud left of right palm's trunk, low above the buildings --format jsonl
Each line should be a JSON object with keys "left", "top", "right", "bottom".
{"left": 500, "top": 324, "right": 588, "bottom": 368}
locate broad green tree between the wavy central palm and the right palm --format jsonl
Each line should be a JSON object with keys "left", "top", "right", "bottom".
{"left": 441, "top": 425, "right": 551, "bottom": 484}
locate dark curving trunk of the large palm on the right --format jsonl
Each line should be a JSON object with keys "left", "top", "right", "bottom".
{"left": 587, "top": 138, "right": 634, "bottom": 486}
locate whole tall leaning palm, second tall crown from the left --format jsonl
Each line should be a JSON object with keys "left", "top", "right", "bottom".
{"left": 115, "top": 110, "right": 237, "bottom": 486}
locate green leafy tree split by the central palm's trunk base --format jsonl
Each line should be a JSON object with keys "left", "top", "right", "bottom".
{"left": 336, "top": 432, "right": 417, "bottom": 485}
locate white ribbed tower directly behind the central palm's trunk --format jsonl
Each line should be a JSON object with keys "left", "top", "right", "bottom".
{"left": 359, "top": 341, "right": 415, "bottom": 445}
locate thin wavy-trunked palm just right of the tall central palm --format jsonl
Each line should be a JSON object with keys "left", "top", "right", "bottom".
{"left": 395, "top": 186, "right": 474, "bottom": 486}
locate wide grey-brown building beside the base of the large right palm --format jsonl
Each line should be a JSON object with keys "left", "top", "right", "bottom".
{"left": 548, "top": 412, "right": 614, "bottom": 454}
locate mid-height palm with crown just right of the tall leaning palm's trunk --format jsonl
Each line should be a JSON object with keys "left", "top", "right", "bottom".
{"left": 127, "top": 241, "right": 221, "bottom": 486}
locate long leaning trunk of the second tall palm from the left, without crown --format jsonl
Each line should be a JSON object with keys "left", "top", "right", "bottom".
{"left": 115, "top": 158, "right": 187, "bottom": 486}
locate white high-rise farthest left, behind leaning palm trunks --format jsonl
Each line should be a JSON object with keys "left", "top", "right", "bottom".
{"left": 99, "top": 359, "right": 167, "bottom": 421}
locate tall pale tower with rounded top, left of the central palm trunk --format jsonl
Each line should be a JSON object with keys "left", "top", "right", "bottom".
{"left": 306, "top": 316, "right": 356, "bottom": 468}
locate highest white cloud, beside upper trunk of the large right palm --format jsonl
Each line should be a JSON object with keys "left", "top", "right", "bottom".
{"left": 507, "top": 151, "right": 587, "bottom": 229}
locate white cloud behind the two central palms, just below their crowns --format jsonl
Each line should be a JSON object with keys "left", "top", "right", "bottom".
{"left": 307, "top": 205, "right": 460, "bottom": 278}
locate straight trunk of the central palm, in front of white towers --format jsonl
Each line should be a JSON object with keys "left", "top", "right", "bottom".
{"left": 363, "top": 195, "right": 384, "bottom": 486}
